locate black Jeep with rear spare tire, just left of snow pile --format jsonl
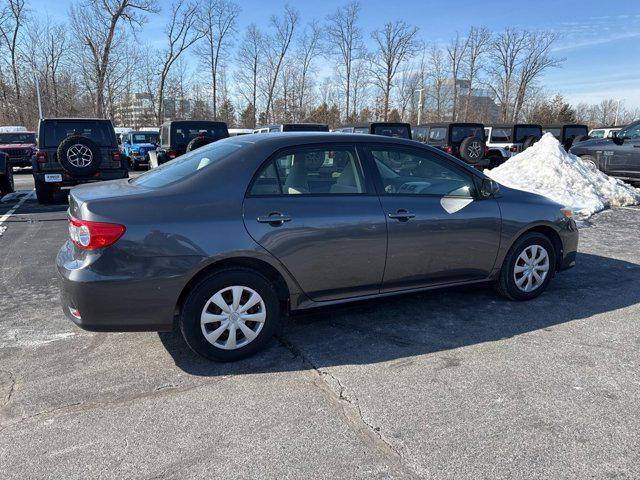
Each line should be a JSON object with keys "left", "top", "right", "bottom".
{"left": 414, "top": 122, "right": 489, "bottom": 168}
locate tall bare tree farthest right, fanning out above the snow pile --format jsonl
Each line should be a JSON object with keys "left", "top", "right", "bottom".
{"left": 512, "top": 32, "right": 561, "bottom": 122}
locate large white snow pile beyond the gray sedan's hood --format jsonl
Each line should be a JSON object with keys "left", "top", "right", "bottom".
{"left": 484, "top": 133, "right": 640, "bottom": 218}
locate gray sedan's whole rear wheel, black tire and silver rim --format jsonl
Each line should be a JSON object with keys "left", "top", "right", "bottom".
{"left": 180, "top": 268, "right": 280, "bottom": 361}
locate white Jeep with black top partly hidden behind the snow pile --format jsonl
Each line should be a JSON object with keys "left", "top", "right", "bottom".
{"left": 484, "top": 123, "right": 542, "bottom": 168}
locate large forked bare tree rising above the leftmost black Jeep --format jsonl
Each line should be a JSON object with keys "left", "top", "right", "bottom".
{"left": 70, "top": 0, "right": 157, "bottom": 117}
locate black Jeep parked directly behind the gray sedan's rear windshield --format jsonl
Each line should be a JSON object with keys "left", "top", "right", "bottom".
{"left": 147, "top": 120, "right": 229, "bottom": 168}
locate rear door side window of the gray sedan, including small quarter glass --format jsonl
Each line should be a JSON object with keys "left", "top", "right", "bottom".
{"left": 250, "top": 146, "right": 366, "bottom": 195}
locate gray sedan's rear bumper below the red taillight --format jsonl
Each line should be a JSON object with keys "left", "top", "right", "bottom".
{"left": 56, "top": 241, "right": 200, "bottom": 332}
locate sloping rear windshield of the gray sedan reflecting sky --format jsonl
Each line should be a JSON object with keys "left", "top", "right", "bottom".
{"left": 130, "top": 141, "right": 242, "bottom": 188}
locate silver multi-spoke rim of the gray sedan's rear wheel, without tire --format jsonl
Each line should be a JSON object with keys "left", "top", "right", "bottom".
{"left": 200, "top": 285, "right": 267, "bottom": 350}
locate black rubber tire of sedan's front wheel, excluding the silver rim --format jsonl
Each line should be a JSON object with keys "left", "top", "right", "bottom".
{"left": 496, "top": 232, "right": 556, "bottom": 301}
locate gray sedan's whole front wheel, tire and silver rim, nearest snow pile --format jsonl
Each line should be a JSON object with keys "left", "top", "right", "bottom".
{"left": 497, "top": 232, "right": 556, "bottom": 300}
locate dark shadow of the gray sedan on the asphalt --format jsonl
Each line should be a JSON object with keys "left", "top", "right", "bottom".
{"left": 159, "top": 253, "right": 640, "bottom": 376}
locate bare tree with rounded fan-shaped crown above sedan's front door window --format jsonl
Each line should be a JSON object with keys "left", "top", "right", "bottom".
{"left": 371, "top": 20, "right": 418, "bottom": 121}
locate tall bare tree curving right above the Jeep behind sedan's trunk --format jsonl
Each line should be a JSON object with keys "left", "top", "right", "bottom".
{"left": 155, "top": 0, "right": 202, "bottom": 124}
